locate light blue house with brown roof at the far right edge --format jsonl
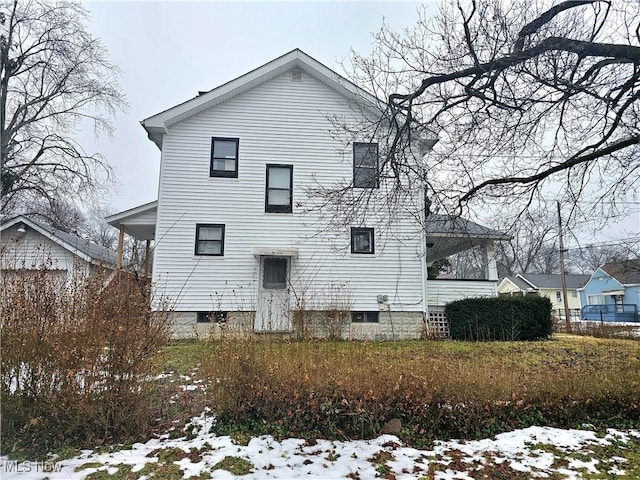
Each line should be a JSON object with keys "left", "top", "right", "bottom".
{"left": 579, "top": 259, "right": 640, "bottom": 322}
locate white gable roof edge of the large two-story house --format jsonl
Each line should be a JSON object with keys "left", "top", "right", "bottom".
{"left": 140, "top": 48, "right": 436, "bottom": 149}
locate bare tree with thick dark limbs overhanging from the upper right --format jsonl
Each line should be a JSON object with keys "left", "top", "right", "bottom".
{"left": 348, "top": 0, "right": 640, "bottom": 224}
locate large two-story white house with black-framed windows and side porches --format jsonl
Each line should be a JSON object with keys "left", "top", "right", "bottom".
{"left": 107, "top": 50, "right": 505, "bottom": 339}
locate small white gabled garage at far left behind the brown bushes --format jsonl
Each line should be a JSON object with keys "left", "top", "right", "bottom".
{"left": 0, "top": 215, "right": 116, "bottom": 281}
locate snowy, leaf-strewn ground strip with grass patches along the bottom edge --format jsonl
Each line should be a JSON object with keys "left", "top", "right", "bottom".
{"left": 0, "top": 413, "right": 640, "bottom": 480}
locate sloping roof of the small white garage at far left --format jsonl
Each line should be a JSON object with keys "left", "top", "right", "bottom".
{"left": 0, "top": 215, "right": 116, "bottom": 265}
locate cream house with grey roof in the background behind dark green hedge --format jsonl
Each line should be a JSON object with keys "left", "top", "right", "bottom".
{"left": 498, "top": 273, "right": 590, "bottom": 315}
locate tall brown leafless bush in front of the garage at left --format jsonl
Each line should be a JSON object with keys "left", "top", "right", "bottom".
{"left": 0, "top": 268, "right": 168, "bottom": 452}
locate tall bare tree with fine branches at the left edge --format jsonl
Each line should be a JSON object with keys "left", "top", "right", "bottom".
{"left": 0, "top": 0, "right": 126, "bottom": 212}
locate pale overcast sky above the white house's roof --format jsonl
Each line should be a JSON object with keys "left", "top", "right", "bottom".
{"left": 80, "top": 1, "right": 640, "bottom": 242}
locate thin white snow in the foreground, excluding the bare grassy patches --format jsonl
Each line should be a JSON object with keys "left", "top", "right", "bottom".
{"left": 0, "top": 412, "right": 640, "bottom": 480}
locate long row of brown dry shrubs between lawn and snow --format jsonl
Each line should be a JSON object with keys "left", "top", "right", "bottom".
{"left": 199, "top": 339, "right": 640, "bottom": 446}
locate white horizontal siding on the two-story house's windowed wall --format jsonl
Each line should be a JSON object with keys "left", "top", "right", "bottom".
{"left": 153, "top": 72, "right": 422, "bottom": 312}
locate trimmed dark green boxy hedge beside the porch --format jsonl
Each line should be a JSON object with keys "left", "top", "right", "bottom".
{"left": 445, "top": 296, "right": 553, "bottom": 341}
